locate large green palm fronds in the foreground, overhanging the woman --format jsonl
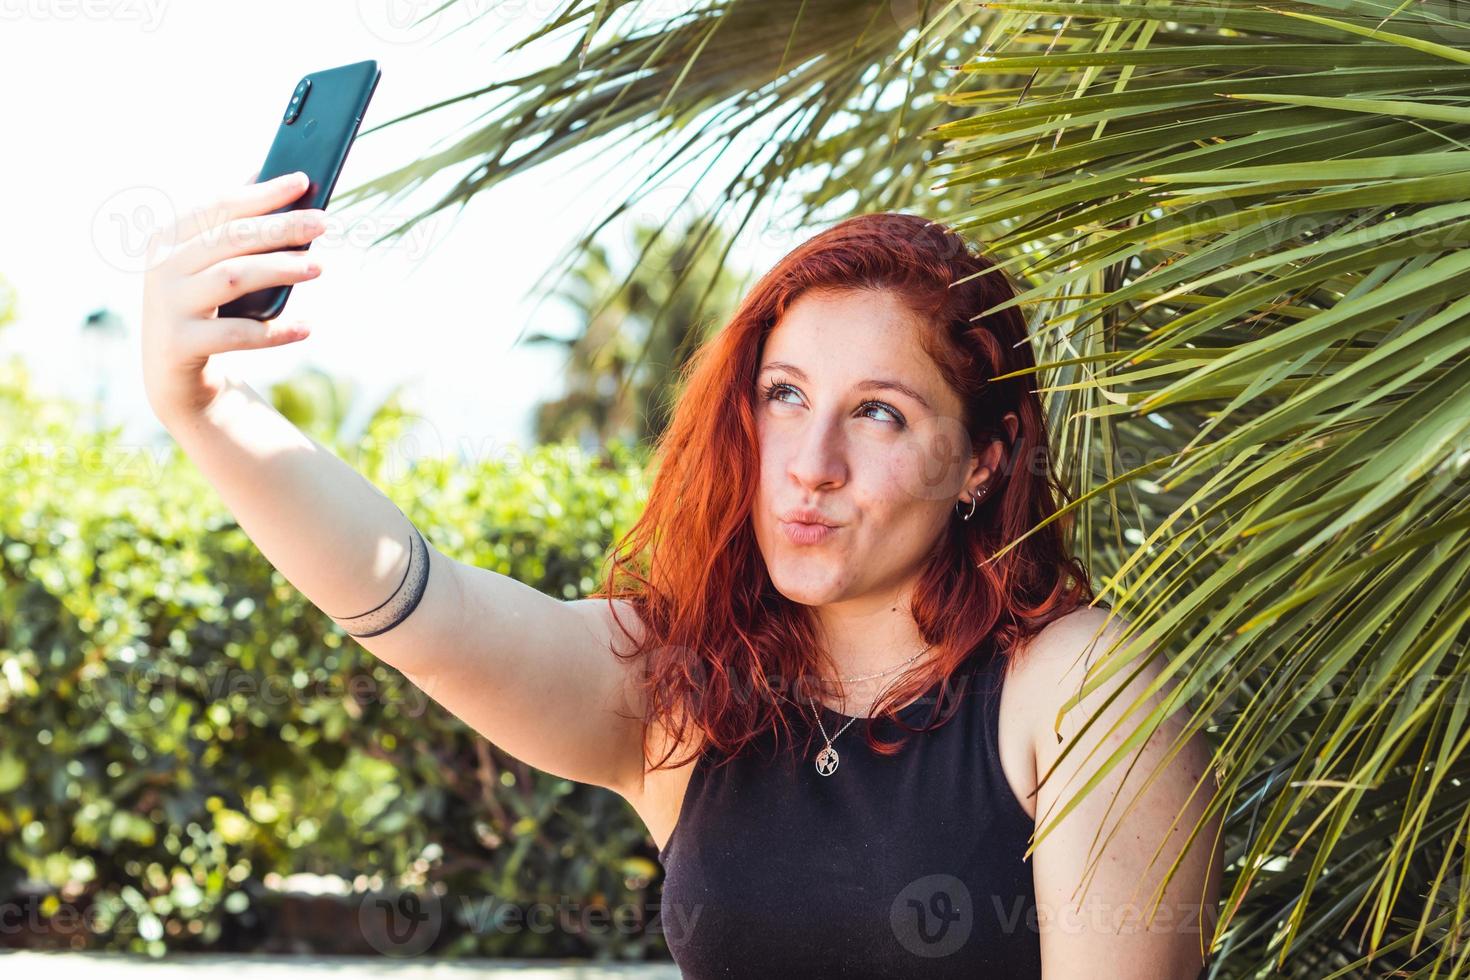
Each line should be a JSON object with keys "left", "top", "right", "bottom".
{"left": 330, "top": 0, "right": 1470, "bottom": 977}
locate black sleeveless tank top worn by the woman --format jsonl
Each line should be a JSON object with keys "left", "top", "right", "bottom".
{"left": 659, "top": 645, "right": 1041, "bottom": 980}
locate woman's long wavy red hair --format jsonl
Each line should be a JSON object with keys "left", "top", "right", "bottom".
{"left": 591, "top": 212, "right": 1094, "bottom": 767}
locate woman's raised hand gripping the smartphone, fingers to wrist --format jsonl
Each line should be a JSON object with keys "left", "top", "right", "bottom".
{"left": 143, "top": 172, "right": 326, "bottom": 425}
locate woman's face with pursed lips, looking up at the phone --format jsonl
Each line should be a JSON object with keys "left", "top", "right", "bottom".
{"left": 754, "top": 289, "right": 986, "bottom": 605}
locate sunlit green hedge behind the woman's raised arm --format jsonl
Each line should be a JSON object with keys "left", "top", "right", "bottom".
{"left": 0, "top": 361, "right": 663, "bottom": 959}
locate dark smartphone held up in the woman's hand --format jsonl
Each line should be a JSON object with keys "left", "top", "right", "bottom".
{"left": 219, "top": 60, "right": 382, "bottom": 320}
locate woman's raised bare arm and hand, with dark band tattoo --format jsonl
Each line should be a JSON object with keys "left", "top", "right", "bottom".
{"left": 143, "top": 178, "right": 642, "bottom": 792}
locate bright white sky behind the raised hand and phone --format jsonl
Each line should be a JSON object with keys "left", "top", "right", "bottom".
{"left": 0, "top": 0, "right": 797, "bottom": 458}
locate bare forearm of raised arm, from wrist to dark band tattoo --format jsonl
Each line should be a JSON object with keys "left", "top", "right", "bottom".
{"left": 165, "top": 371, "right": 413, "bottom": 631}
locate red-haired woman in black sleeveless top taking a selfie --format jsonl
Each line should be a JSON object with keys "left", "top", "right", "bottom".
{"left": 143, "top": 176, "right": 1220, "bottom": 980}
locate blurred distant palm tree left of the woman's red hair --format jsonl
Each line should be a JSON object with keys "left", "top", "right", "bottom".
{"left": 526, "top": 217, "right": 738, "bottom": 451}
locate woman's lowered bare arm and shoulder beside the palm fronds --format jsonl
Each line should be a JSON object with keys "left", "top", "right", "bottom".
{"left": 1017, "top": 607, "right": 1223, "bottom": 977}
